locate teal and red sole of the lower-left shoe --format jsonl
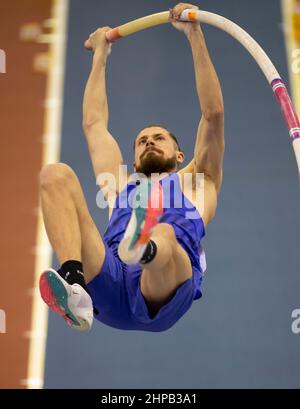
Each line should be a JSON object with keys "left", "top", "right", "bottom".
{"left": 40, "top": 270, "right": 87, "bottom": 330}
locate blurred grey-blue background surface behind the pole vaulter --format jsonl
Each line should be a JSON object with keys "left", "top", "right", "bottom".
{"left": 45, "top": 0, "right": 300, "bottom": 388}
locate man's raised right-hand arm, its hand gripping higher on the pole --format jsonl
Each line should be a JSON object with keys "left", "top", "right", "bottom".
{"left": 171, "top": 3, "right": 225, "bottom": 223}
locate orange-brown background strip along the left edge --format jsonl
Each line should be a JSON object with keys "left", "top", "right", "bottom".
{"left": 0, "top": 0, "right": 51, "bottom": 388}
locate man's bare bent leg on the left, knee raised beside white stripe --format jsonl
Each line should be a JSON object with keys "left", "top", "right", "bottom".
{"left": 40, "top": 163, "right": 105, "bottom": 283}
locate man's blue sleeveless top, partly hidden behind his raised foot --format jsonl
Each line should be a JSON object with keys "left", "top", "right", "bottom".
{"left": 104, "top": 173, "right": 206, "bottom": 299}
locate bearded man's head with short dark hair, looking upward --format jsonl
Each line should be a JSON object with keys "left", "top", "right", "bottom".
{"left": 134, "top": 126, "right": 184, "bottom": 176}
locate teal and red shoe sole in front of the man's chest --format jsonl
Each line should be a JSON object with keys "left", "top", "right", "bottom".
{"left": 118, "top": 182, "right": 163, "bottom": 264}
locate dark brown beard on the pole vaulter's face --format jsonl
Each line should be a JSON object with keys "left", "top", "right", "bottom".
{"left": 136, "top": 151, "right": 177, "bottom": 177}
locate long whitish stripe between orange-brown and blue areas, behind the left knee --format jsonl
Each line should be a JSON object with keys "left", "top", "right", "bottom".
{"left": 21, "top": 0, "right": 69, "bottom": 389}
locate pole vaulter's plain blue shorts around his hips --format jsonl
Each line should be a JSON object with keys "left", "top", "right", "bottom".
{"left": 88, "top": 240, "right": 201, "bottom": 332}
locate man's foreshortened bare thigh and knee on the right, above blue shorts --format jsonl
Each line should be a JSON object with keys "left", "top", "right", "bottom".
{"left": 141, "top": 223, "right": 193, "bottom": 311}
